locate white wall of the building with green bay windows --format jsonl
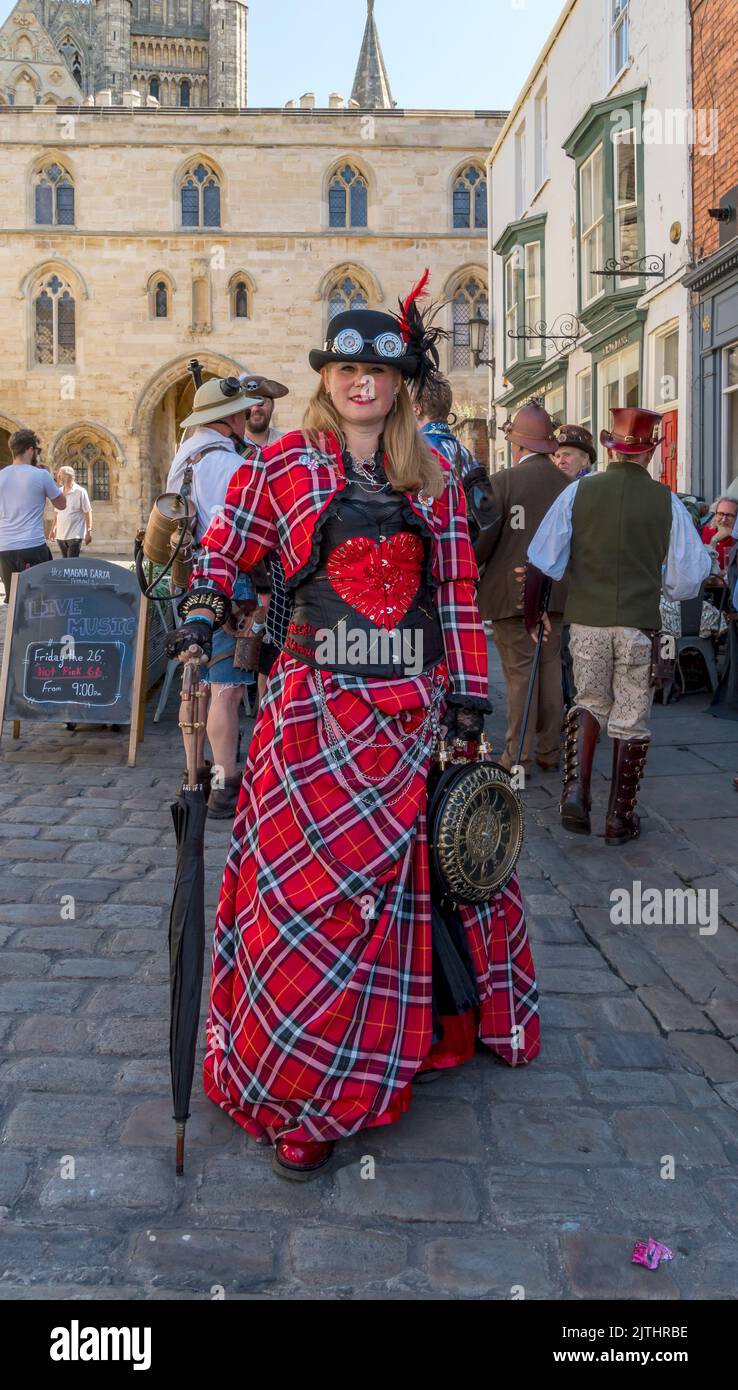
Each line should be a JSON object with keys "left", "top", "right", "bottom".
{"left": 489, "top": 0, "right": 699, "bottom": 491}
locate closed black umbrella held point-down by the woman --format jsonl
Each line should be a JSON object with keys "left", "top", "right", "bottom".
{"left": 170, "top": 657, "right": 210, "bottom": 1173}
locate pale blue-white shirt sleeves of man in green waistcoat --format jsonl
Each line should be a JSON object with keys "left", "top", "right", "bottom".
{"left": 528, "top": 473, "right": 712, "bottom": 599}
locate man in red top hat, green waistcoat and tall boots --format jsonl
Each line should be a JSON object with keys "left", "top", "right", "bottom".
{"left": 528, "top": 407, "right": 710, "bottom": 845}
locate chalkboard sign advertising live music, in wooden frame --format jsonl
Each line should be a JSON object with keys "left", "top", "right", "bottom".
{"left": 0, "top": 556, "right": 146, "bottom": 762}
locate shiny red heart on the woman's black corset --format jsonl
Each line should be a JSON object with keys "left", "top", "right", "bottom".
{"left": 325, "top": 531, "right": 423, "bottom": 631}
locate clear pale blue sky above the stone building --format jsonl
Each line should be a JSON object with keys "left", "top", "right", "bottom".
{"left": 0, "top": 0, "right": 563, "bottom": 110}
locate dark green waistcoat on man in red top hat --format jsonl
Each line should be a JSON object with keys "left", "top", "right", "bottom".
{"left": 564, "top": 461, "right": 671, "bottom": 628}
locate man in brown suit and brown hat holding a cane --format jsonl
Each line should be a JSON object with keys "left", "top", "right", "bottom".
{"left": 475, "top": 403, "right": 568, "bottom": 770}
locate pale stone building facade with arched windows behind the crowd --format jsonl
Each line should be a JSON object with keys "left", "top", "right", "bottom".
{"left": 0, "top": 25, "right": 505, "bottom": 549}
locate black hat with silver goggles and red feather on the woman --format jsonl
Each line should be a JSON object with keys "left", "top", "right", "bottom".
{"left": 309, "top": 270, "right": 449, "bottom": 395}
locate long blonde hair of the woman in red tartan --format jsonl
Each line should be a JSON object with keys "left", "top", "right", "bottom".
{"left": 303, "top": 377, "right": 445, "bottom": 498}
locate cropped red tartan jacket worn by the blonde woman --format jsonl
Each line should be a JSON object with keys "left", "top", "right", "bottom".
{"left": 190, "top": 430, "right": 489, "bottom": 709}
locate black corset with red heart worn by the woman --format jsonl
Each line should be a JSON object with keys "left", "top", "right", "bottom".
{"left": 284, "top": 470, "right": 445, "bottom": 678}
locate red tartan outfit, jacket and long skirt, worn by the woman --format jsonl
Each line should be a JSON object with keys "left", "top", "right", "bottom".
{"left": 193, "top": 431, "right": 539, "bottom": 1141}
